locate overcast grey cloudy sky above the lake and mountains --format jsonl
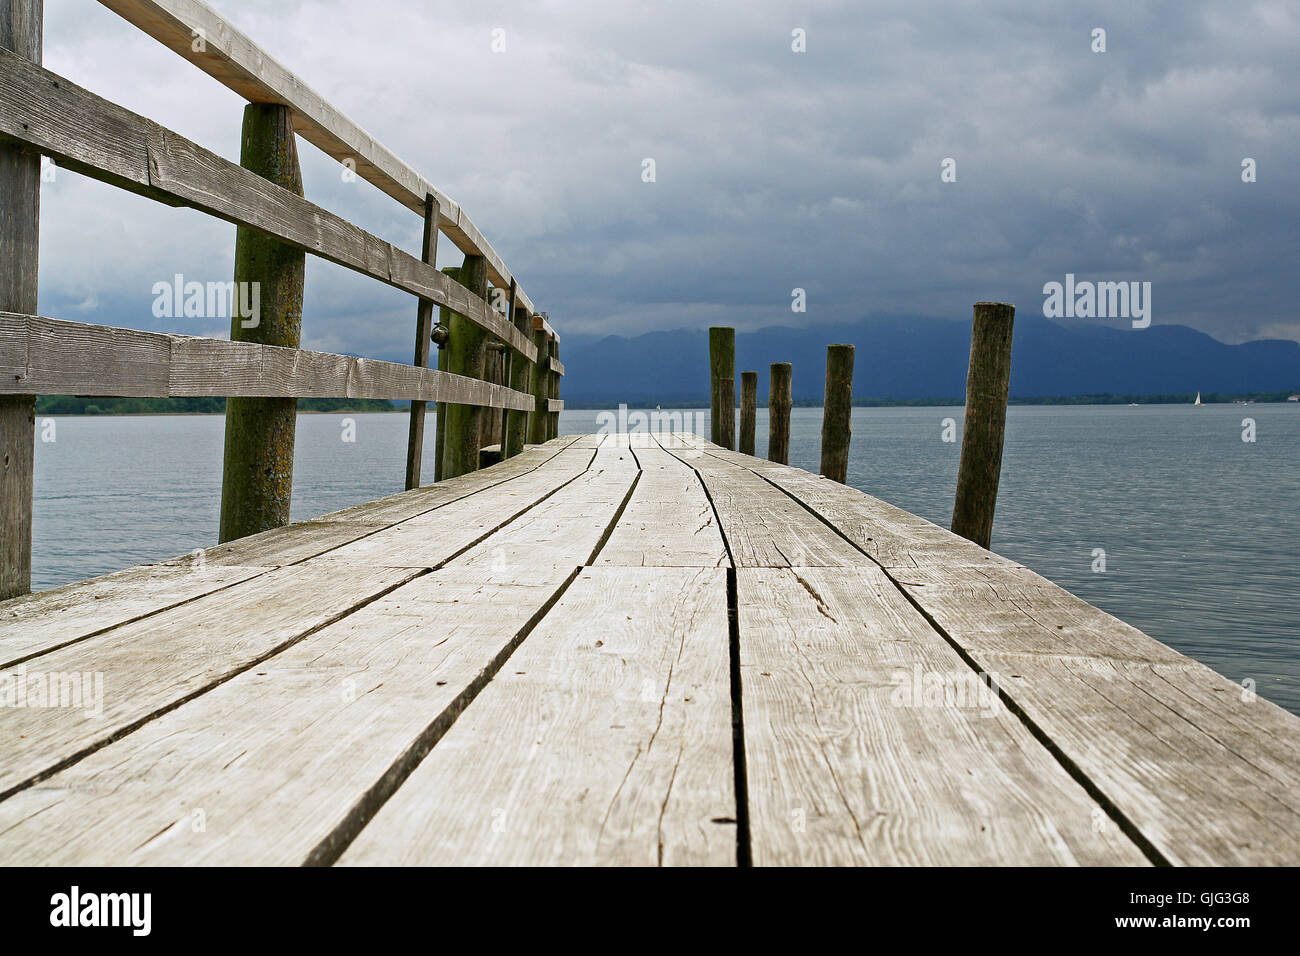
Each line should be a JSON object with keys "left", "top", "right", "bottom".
{"left": 30, "top": 0, "right": 1300, "bottom": 360}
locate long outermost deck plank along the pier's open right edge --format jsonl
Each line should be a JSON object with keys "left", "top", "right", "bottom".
{"left": 711, "top": 439, "right": 1300, "bottom": 865}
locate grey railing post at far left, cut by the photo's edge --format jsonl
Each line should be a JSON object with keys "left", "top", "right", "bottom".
{"left": 0, "top": 0, "right": 43, "bottom": 601}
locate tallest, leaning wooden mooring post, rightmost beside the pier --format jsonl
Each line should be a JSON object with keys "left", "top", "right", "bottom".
{"left": 953, "top": 302, "right": 1015, "bottom": 548}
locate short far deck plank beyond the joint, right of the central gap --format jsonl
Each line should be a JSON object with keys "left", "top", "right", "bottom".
{"left": 660, "top": 449, "right": 863, "bottom": 567}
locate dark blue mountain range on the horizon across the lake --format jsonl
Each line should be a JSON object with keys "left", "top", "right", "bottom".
{"left": 560, "top": 315, "right": 1300, "bottom": 406}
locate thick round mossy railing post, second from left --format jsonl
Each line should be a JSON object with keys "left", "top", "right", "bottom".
{"left": 218, "top": 103, "right": 307, "bottom": 541}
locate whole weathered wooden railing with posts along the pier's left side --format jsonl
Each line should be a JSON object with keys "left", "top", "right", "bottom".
{"left": 0, "top": 0, "right": 564, "bottom": 600}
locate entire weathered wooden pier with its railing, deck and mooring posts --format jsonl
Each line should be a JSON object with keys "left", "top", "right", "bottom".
{"left": 0, "top": 0, "right": 1300, "bottom": 866}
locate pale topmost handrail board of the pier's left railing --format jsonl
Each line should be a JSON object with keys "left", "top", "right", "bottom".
{"left": 100, "top": 0, "right": 533, "bottom": 311}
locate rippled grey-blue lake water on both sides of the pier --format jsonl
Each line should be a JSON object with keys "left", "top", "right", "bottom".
{"left": 33, "top": 405, "right": 1300, "bottom": 713}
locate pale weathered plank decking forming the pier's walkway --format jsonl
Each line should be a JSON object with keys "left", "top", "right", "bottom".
{"left": 0, "top": 434, "right": 1300, "bottom": 865}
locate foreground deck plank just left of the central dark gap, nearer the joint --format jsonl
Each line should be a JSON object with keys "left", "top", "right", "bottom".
{"left": 342, "top": 567, "right": 736, "bottom": 866}
